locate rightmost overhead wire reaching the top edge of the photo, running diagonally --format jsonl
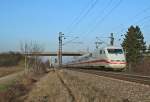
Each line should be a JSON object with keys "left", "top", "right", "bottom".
{"left": 88, "top": 0, "right": 122, "bottom": 34}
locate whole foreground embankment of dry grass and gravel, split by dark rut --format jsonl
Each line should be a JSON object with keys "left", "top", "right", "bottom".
{"left": 26, "top": 69, "right": 150, "bottom": 102}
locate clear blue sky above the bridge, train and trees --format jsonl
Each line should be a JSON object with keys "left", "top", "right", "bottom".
{"left": 0, "top": 0, "right": 150, "bottom": 52}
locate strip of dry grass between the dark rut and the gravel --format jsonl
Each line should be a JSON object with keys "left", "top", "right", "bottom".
{"left": 60, "top": 71, "right": 123, "bottom": 102}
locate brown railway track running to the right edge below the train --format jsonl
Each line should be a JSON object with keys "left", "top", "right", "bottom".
{"left": 69, "top": 68, "right": 150, "bottom": 85}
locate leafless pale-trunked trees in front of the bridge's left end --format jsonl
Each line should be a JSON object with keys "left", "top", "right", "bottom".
{"left": 20, "top": 41, "right": 45, "bottom": 73}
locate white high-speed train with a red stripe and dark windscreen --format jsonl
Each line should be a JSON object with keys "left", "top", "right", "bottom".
{"left": 65, "top": 46, "right": 126, "bottom": 70}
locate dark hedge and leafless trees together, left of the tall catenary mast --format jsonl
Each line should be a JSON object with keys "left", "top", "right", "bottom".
{"left": 0, "top": 41, "right": 49, "bottom": 73}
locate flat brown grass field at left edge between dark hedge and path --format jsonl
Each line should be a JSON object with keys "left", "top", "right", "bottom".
{"left": 0, "top": 67, "right": 23, "bottom": 77}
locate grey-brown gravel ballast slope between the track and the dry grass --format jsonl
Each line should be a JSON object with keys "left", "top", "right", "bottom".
{"left": 62, "top": 70, "right": 150, "bottom": 102}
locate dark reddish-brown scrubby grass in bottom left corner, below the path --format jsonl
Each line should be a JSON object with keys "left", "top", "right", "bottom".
{"left": 0, "top": 76, "right": 36, "bottom": 102}
